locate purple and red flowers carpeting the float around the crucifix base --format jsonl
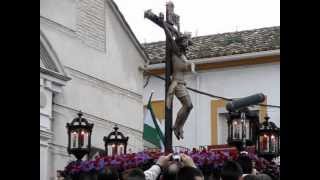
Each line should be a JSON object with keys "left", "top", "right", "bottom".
{"left": 64, "top": 149, "right": 280, "bottom": 177}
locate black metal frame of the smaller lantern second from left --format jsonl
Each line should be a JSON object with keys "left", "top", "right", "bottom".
{"left": 103, "top": 125, "right": 129, "bottom": 155}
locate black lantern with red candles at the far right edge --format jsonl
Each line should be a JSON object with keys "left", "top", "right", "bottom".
{"left": 256, "top": 116, "right": 280, "bottom": 160}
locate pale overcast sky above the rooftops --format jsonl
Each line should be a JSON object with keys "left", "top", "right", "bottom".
{"left": 114, "top": 0, "right": 280, "bottom": 43}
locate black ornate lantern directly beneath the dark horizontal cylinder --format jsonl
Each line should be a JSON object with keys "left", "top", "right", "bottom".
{"left": 228, "top": 108, "right": 259, "bottom": 151}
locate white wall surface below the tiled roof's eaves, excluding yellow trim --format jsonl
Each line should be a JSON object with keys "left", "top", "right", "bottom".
{"left": 144, "top": 63, "right": 280, "bottom": 148}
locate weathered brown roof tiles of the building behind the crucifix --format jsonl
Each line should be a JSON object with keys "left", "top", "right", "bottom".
{"left": 142, "top": 26, "right": 280, "bottom": 64}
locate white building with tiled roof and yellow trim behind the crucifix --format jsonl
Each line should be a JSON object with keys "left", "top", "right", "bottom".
{"left": 144, "top": 27, "right": 280, "bottom": 148}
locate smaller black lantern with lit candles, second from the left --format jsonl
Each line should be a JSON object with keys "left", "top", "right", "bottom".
{"left": 103, "top": 126, "right": 129, "bottom": 155}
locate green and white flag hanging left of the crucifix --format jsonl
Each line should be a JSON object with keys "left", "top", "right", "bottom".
{"left": 143, "top": 93, "right": 164, "bottom": 150}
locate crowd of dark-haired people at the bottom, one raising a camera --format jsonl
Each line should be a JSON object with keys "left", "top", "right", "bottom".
{"left": 98, "top": 154, "right": 273, "bottom": 180}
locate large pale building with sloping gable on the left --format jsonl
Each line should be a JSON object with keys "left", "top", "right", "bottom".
{"left": 40, "top": 0, "right": 148, "bottom": 180}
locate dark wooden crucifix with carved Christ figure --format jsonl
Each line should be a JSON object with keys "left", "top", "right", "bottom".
{"left": 144, "top": 2, "right": 195, "bottom": 152}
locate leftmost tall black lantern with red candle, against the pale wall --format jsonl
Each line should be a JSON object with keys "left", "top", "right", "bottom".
{"left": 66, "top": 111, "right": 93, "bottom": 161}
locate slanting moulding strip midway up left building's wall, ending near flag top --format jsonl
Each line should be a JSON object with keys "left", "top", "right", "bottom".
{"left": 65, "top": 66, "right": 142, "bottom": 103}
